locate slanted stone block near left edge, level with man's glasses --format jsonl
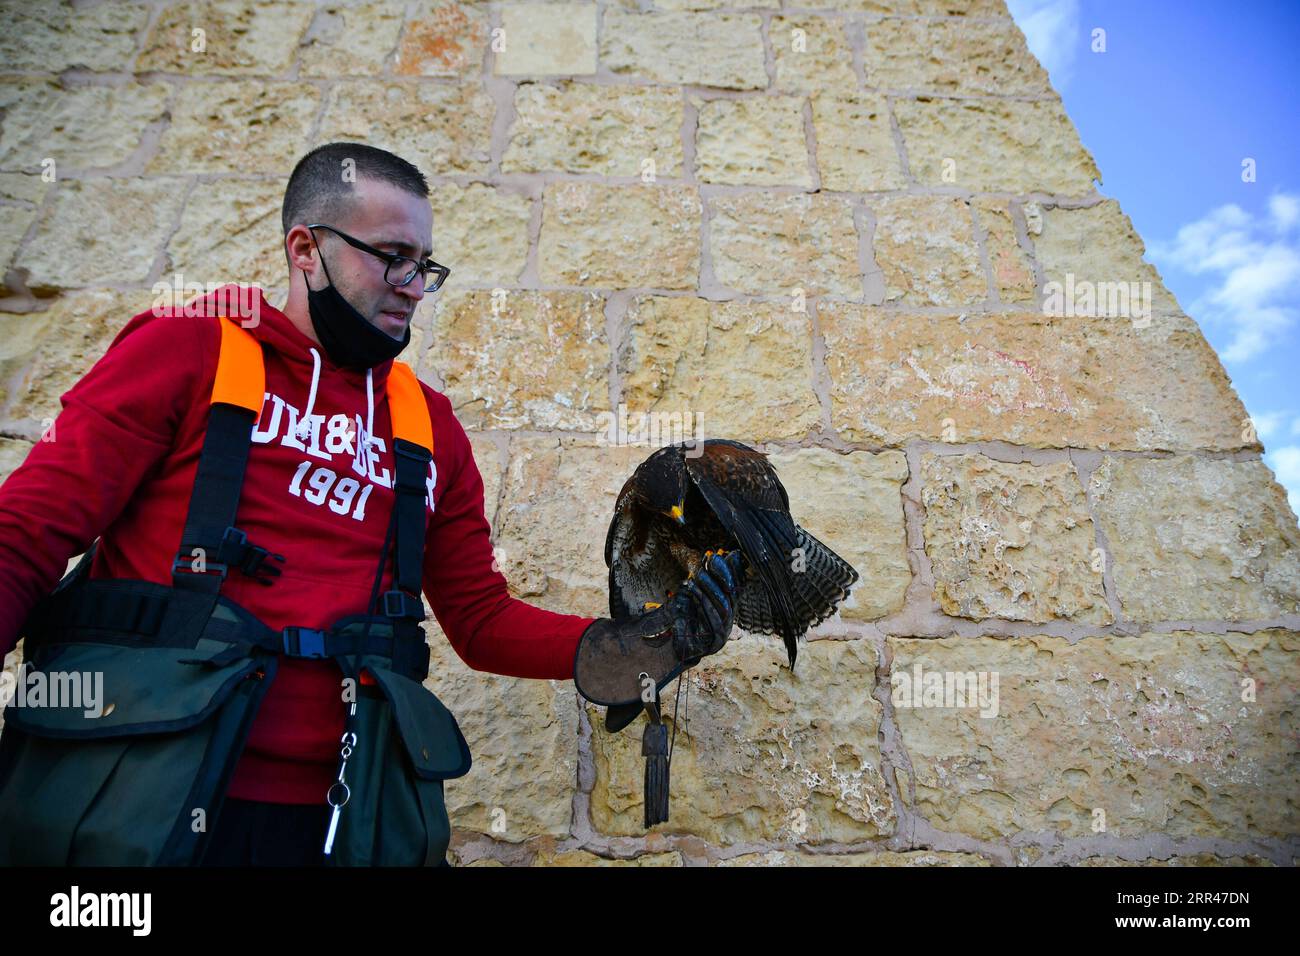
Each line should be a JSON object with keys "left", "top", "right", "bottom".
{"left": 14, "top": 178, "right": 185, "bottom": 290}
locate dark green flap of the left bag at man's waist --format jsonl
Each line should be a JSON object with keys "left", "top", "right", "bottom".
{"left": 4, "top": 639, "right": 259, "bottom": 739}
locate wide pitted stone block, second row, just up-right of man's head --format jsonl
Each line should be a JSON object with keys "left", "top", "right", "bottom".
{"left": 501, "top": 81, "right": 683, "bottom": 177}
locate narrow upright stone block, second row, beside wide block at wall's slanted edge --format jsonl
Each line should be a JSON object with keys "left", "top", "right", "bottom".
{"left": 813, "top": 94, "right": 907, "bottom": 193}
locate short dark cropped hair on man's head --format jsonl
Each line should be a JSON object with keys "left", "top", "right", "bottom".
{"left": 280, "top": 143, "right": 429, "bottom": 243}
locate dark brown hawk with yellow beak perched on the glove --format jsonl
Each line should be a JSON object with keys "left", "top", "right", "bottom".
{"left": 605, "top": 438, "right": 858, "bottom": 670}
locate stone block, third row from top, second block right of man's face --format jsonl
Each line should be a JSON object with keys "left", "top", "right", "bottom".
{"left": 709, "top": 193, "right": 862, "bottom": 295}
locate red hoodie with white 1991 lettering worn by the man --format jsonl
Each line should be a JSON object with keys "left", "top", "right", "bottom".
{"left": 0, "top": 289, "right": 594, "bottom": 804}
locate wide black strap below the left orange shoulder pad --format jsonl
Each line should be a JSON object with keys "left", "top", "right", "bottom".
{"left": 172, "top": 402, "right": 256, "bottom": 594}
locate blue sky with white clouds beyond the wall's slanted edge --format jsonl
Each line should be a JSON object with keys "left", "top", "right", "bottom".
{"left": 1009, "top": 0, "right": 1300, "bottom": 528}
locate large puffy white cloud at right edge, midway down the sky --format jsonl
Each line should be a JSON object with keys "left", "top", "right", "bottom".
{"left": 1149, "top": 193, "right": 1300, "bottom": 362}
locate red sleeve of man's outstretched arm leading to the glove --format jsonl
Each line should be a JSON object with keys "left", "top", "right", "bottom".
{"left": 424, "top": 400, "right": 595, "bottom": 680}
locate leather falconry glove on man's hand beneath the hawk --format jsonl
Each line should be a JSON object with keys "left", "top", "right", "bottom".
{"left": 573, "top": 551, "right": 744, "bottom": 713}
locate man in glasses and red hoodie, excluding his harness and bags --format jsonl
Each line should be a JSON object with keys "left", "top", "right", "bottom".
{"left": 0, "top": 143, "right": 735, "bottom": 865}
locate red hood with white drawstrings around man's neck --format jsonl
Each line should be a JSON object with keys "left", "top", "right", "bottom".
{"left": 203, "top": 284, "right": 394, "bottom": 478}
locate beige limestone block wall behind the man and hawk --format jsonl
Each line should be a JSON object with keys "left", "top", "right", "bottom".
{"left": 0, "top": 0, "right": 1300, "bottom": 865}
